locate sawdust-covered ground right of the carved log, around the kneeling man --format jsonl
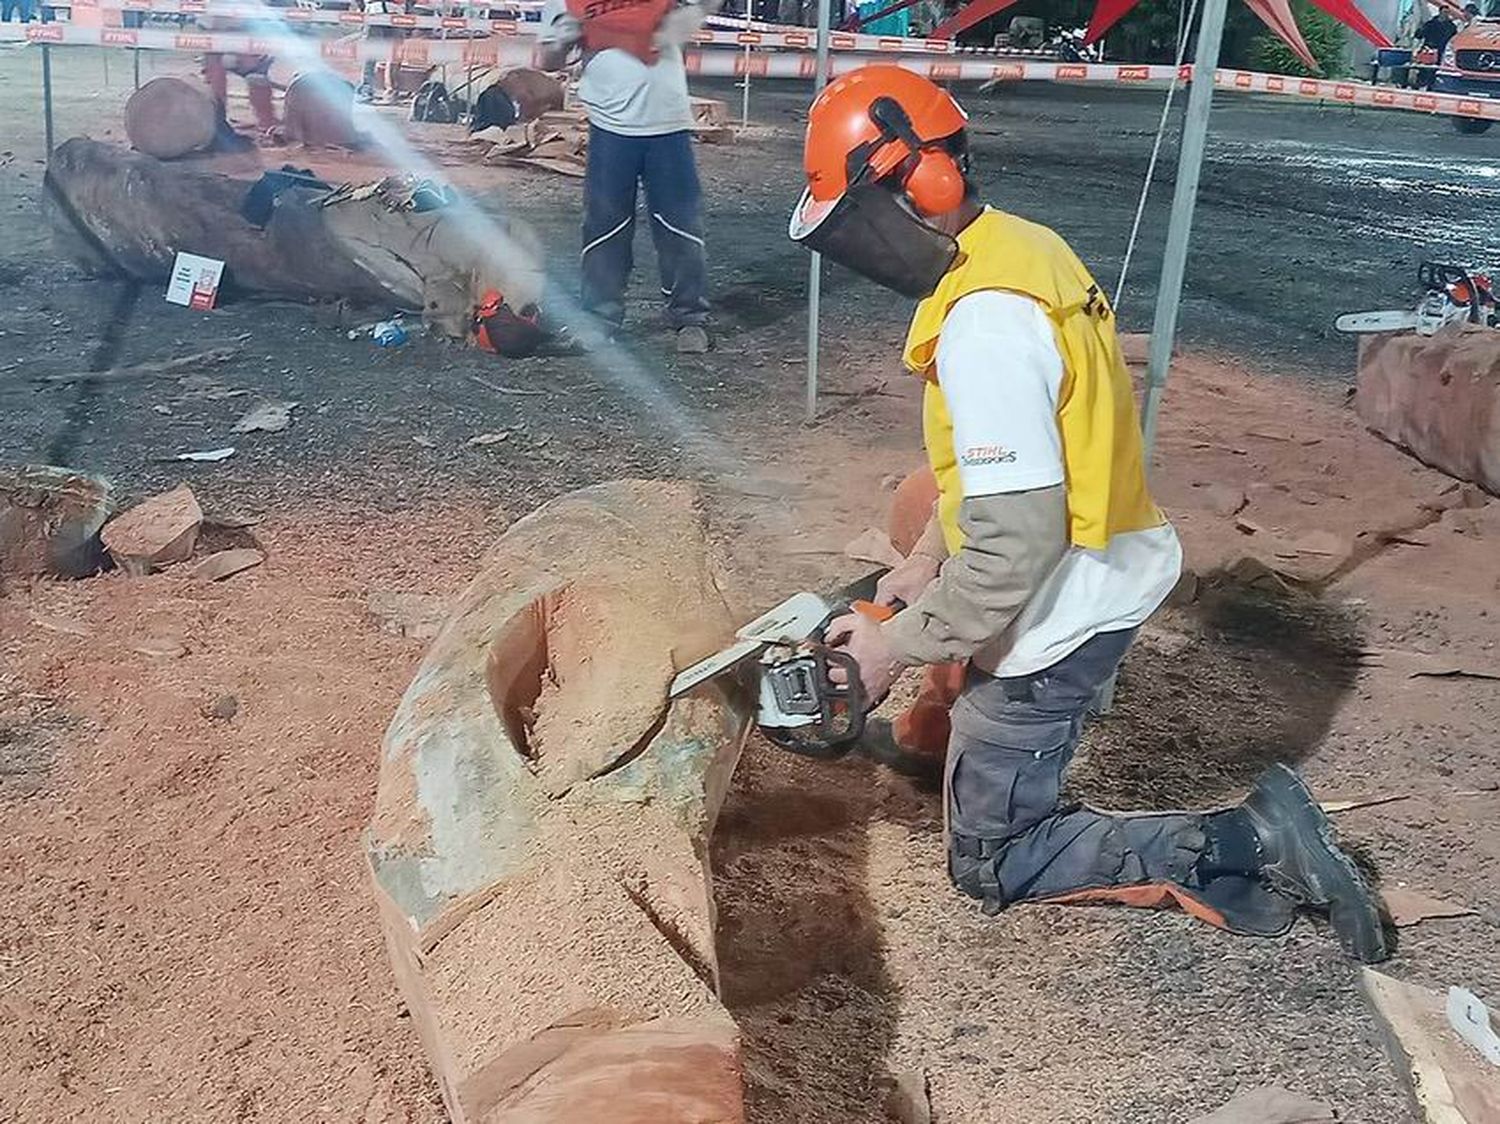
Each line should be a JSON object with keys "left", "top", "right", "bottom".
{"left": 716, "top": 351, "right": 1500, "bottom": 1124}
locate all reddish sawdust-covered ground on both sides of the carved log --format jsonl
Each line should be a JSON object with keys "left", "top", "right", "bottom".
{"left": 0, "top": 352, "right": 1500, "bottom": 1124}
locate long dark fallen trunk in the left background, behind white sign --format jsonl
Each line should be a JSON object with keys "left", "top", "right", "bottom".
{"left": 47, "top": 138, "right": 546, "bottom": 339}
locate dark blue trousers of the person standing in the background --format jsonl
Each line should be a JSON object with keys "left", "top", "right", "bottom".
{"left": 582, "top": 125, "right": 708, "bottom": 327}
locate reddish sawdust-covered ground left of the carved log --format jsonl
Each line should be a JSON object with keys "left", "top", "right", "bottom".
{"left": 0, "top": 506, "right": 497, "bottom": 1121}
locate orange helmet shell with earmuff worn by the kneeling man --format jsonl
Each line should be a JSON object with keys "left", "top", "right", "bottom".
{"left": 803, "top": 65, "right": 969, "bottom": 223}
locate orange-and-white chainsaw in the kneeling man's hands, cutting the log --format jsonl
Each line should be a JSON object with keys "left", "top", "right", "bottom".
{"left": 669, "top": 570, "right": 903, "bottom": 761}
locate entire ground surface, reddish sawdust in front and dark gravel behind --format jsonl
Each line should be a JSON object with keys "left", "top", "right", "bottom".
{"left": 0, "top": 39, "right": 1500, "bottom": 1124}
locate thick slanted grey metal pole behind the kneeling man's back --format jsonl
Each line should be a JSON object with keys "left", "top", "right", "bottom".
{"left": 1143, "top": 0, "right": 1229, "bottom": 461}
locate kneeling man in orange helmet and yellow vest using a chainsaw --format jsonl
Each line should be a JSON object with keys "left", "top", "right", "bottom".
{"left": 791, "top": 66, "right": 1386, "bottom": 960}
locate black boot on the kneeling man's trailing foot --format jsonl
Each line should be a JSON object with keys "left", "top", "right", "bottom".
{"left": 1242, "top": 765, "right": 1391, "bottom": 963}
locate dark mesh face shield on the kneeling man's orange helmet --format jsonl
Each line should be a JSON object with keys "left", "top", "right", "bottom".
{"left": 788, "top": 183, "right": 959, "bottom": 300}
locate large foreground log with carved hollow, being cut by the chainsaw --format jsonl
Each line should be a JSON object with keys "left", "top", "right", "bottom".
{"left": 366, "top": 482, "right": 749, "bottom": 1124}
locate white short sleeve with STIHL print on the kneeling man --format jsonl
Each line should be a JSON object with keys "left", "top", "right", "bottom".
{"left": 938, "top": 290, "right": 1064, "bottom": 497}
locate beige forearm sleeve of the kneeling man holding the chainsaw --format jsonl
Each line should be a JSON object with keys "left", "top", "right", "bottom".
{"left": 881, "top": 485, "right": 1068, "bottom": 665}
